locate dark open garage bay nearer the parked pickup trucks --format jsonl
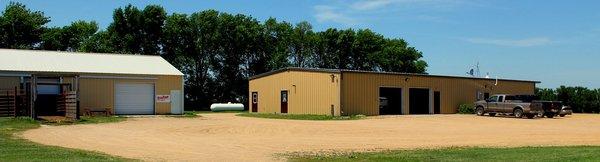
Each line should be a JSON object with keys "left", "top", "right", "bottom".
{"left": 408, "top": 88, "right": 429, "bottom": 114}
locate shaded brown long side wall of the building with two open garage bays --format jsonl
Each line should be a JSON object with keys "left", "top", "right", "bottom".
{"left": 341, "top": 72, "right": 535, "bottom": 115}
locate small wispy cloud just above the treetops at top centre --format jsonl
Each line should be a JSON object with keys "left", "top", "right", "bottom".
{"left": 314, "top": 5, "right": 357, "bottom": 26}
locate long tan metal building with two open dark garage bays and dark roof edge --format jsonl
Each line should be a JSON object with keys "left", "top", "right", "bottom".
{"left": 249, "top": 68, "right": 539, "bottom": 116}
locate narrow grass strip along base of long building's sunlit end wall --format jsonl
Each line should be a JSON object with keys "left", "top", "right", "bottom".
{"left": 237, "top": 113, "right": 365, "bottom": 120}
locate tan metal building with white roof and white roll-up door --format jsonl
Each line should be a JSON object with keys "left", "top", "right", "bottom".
{"left": 0, "top": 49, "right": 184, "bottom": 116}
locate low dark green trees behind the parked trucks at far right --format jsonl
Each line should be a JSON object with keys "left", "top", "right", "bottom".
{"left": 535, "top": 86, "right": 600, "bottom": 113}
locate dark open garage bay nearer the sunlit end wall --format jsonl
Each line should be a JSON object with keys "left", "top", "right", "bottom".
{"left": 379, "top": 87, "right": 402, "bottom": 115}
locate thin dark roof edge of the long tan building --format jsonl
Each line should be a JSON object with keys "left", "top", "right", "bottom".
{"left": 250, "top": 67, "right": 541, "bottom": 83}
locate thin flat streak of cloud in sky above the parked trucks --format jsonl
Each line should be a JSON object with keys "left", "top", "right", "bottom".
{"left": 465, "top": 37, "right": 552, "bottom": 47}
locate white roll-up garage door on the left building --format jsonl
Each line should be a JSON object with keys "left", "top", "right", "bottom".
{"left": 115, "top": 83, "right": 154, "bottom": 115}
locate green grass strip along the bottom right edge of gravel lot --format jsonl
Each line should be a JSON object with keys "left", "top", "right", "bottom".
{"left": 290, "top": 146, "right": 600, "bottom": 162}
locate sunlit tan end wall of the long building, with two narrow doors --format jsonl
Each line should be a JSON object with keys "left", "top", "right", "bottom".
{"left": 248, "top": 71, "right": 340, "bottom": 116}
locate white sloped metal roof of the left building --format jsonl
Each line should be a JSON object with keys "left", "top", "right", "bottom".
{"left": 0, "top": 49, "right": 183, "bottom": 75}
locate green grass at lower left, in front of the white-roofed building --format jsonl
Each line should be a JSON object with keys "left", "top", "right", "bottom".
{"left": 0, "top": 118, "right": 134, "bottom": 161}
